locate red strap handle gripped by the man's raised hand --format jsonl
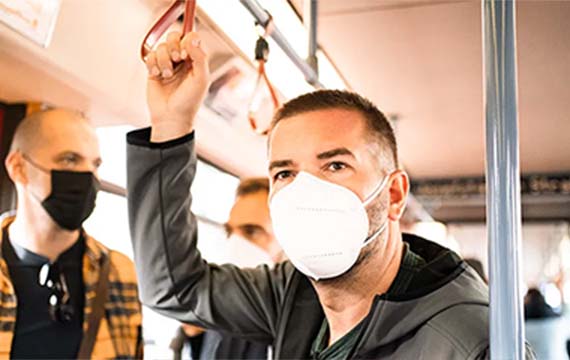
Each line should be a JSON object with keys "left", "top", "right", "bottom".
{"left": 141, "top": 0, "right": 196, "bottom": 61}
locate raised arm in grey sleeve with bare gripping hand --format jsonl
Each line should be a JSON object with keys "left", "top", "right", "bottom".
{"left": 127, "top": 33, "right": 293, "bottom": 342}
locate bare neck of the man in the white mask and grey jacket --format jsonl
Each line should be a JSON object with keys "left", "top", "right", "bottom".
{"left": 313, "top": 224, "right": 404, "bottom": 345}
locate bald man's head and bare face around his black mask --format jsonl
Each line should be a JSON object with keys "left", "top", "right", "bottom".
{"left": 7, "top": 110, "right": 101, "bottom": 206}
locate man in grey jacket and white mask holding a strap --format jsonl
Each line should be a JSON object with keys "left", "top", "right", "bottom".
{"left": 128, "top": 33, "right": 532, "bottom": 359}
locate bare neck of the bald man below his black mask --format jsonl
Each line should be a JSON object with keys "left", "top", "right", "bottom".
{"left": 8, "top": 202, "right": 79, "bottom": 262}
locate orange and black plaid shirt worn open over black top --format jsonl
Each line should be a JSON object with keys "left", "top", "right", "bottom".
{"left": 0, "top": 216, "right": 143, "bottom": 360}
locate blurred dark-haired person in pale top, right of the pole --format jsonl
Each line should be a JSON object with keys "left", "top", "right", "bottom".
{"left": 524, "top": 288, "right": 568, "bottom": 360}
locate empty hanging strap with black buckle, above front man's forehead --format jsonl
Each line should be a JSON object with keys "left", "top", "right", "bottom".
{"left": 247, "top": 21, "right": 279, "bottom": 135}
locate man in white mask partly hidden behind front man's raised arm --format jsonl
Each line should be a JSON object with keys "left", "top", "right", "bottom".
{"left": 170, "top": 178, "right": 284, "bottom": 360}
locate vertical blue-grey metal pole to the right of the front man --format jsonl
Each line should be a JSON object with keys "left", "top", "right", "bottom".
{"left": 482, "top": 0, "right": 525, "bottom": 360}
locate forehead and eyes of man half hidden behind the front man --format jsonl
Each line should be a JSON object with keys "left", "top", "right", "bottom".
{"left": 226, "top": 190, "right": 276, "bottom": 251}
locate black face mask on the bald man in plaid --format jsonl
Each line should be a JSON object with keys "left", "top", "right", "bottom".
{"left": 24, "top": 156, "right": 101, "bottom": 230}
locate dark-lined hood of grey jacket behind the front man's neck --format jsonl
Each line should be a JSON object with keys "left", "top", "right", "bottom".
{"left": 356, "top": 234, "right": 488, "bottom": 353}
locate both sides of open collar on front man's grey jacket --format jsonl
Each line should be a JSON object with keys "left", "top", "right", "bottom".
{"left": 275, "top": 234, "right": 488, "bottom": 359}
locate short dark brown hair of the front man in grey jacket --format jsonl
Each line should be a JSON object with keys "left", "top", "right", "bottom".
{"left": 271, "top": 90, "right": 398, "bottom": 168}
